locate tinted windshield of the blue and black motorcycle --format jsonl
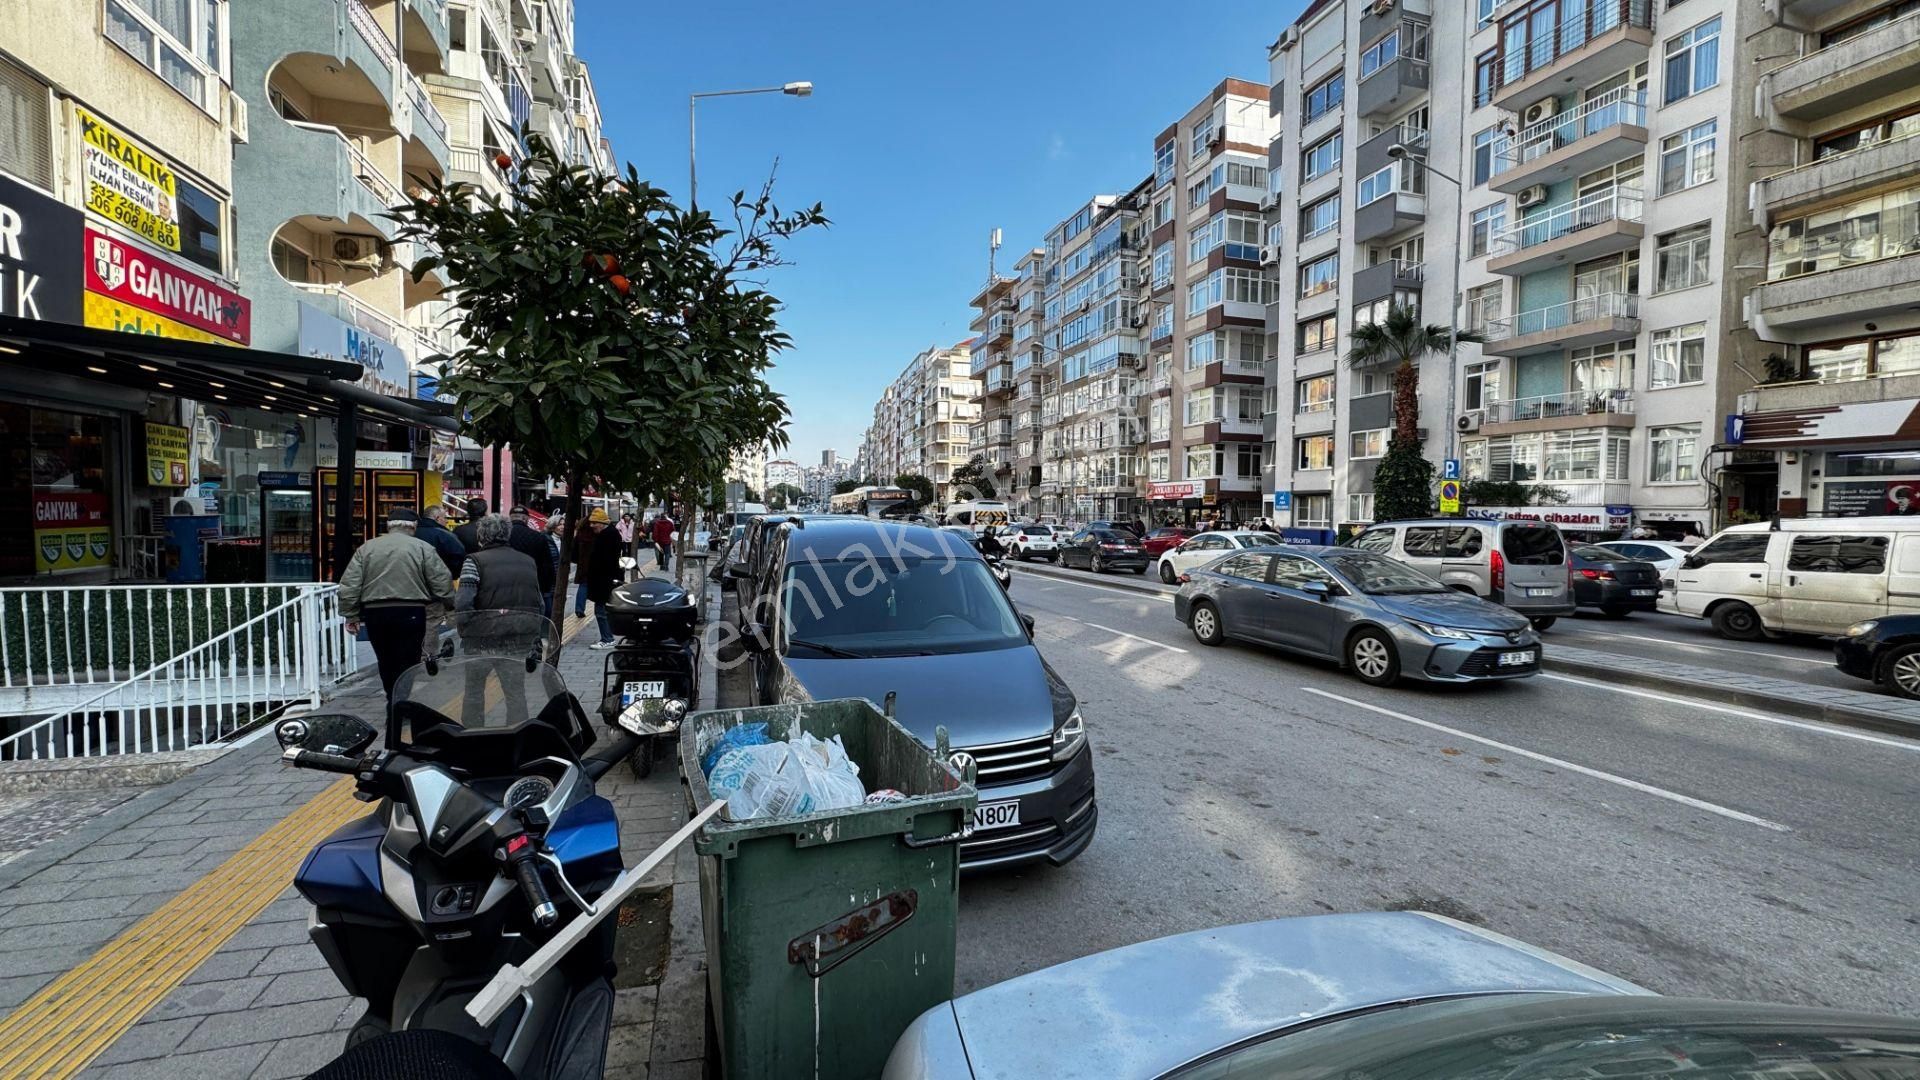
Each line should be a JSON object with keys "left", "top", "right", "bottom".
{"left": 394, "top": 611, "right": 566, "bottom": 742}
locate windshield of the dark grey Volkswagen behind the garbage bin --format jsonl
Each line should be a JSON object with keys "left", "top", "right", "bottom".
{"left": 781, "top": 557, "right": 1027, "bottom": 657}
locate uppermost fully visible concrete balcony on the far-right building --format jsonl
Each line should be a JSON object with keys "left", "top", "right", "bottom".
{"left": 1757, "top": 13, "right": 1920, "bottom": 126}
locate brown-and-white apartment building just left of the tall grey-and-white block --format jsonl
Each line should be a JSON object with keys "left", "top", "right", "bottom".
{"left": 1142, "top": 79, "right": 1275, "bottom": 523}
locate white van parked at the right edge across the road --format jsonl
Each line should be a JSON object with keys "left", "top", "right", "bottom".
{"left": 1661, "top": 517, "right": 1920, "bottom": 642}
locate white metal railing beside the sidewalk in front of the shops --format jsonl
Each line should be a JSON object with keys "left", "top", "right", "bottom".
{"left": 0, "top": 584, "right": 359, "bottom": 761}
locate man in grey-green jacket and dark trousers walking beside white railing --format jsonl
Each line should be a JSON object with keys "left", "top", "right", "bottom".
{"left": 340, "top": 507, "right": 453, "bottom": 707}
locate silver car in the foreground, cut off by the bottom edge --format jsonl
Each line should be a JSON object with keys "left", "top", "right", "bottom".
{"left": 881, "top": 911, "right": 1920, "bottom": 1080}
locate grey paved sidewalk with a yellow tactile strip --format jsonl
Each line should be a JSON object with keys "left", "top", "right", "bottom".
{"left": 0, "top": 580, "right": 710, "bottom": 1080}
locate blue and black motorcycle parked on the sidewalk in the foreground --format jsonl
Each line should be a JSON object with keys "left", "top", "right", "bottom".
{"left": 275, "top": 611, "right": 634, "bottom": 1080}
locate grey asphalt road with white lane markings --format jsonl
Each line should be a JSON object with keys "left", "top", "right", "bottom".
{"left": 960, "top": 575, "right": 1920, "bottom": 1015}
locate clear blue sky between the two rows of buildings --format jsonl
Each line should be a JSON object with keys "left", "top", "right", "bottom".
{"left": 576, "top": 0, "right": 1304, "bottom": 463}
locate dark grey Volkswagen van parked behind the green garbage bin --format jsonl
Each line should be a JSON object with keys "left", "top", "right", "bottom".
{"left": 741, "top": 515, "right": 1098, "bottom": 869}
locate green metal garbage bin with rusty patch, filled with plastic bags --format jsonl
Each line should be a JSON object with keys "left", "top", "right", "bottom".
{"left": 680, "top": 700, "right": 977, "bottom": 1080}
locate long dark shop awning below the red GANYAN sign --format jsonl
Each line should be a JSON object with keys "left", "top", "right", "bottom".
{"left": 0, "top": 317, "right": 459, "bottom": 432}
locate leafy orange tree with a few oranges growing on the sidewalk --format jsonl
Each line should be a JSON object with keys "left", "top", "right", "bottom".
{"left": 392, "top": 133, "right": 828, "bottom": 611}
